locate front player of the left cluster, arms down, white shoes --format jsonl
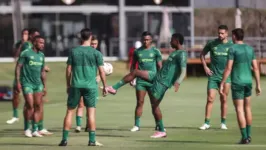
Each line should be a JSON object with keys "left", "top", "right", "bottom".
{"left": 16, "top": 35, "right": 46, "bottom": 137}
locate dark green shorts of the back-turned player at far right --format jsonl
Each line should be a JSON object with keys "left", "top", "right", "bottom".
{"left": 231, "top": 83, "right": 252, "bottom": 100}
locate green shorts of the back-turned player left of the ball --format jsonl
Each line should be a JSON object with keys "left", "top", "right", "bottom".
{"left": 67, "top": 87, "right": 99, "bottom": 108}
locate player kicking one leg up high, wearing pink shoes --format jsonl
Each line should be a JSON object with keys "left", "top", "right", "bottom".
{"left": 107, "top": 33, "right": 187, "bottom": 138}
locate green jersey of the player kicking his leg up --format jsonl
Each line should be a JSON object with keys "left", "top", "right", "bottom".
{"left": 155, "top": 50, "right": 187, "bottom": 88}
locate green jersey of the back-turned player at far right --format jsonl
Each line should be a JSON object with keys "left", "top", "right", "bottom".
{"left": 228, "top": 44, "right": 256, "bottom": 85}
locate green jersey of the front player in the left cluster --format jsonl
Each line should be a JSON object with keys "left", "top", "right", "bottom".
{"left": 18, "top": 48, "right": 45, "bottom": 85}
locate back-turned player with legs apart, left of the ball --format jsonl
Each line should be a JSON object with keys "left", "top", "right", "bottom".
{"left": 59, "top": 28, "right": 107, "bottom": 146}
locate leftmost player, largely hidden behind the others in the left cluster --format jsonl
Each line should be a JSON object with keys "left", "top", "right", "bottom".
{"left": 6, "top": 29, "right": 29, "bottom": 124}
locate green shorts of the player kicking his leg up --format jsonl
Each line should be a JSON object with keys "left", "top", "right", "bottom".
{"left": 150, "top": 81, "right": 168, "bottom": 101}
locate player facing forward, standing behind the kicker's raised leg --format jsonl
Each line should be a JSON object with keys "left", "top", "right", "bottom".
{"left": 129, "top": 32, "right": 162, "bottom": 132}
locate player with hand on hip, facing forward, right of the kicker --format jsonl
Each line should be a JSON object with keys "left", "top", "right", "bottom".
{"left": 199, "top": 25, "right": 233, "bottom": 130}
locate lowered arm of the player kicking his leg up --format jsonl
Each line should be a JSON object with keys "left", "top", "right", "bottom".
{"left": 175, "top": 52, "right": 187, "bottom": 92}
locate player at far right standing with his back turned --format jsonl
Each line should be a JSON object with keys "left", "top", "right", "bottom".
{"left": 220, "top": 28, "right": 261, "bottom": 144}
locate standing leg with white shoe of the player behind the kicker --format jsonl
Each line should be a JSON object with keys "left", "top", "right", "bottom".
{"left": 131, "top": 89, "right": 147, "bottom": 132}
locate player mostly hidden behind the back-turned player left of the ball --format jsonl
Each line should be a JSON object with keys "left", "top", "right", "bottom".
{"left": 75, "top": 36, "right": 100, "bottom": 132}
